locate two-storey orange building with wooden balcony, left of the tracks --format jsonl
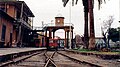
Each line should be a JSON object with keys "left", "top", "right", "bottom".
{"left": 0, "top": 0, "right": 34, "bottom": 46}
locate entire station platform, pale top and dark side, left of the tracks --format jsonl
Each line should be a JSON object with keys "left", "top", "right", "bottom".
{"left": 0, "top": 48, "right": 46, "bottom": 67}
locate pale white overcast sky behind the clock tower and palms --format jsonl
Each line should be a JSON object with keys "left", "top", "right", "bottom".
{"left": 21, "top": 0, "right": 120, "bottom": 37}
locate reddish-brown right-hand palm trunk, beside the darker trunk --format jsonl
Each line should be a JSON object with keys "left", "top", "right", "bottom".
{"left": 88, "top": 0, "right": 95, "bottom": 49}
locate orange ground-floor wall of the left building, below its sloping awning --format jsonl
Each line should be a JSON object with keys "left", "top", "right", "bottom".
{"left": 0, "top": 10, "right": 15, "bottom": 47}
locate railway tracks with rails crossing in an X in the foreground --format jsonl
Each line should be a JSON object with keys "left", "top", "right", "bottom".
{"left": 3, "top": 51, "right": 99, "bottom": 67}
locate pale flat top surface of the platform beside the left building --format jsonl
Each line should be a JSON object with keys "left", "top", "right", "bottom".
{"left": 0, "top": 48, "right": 46, "bottom": 56}
